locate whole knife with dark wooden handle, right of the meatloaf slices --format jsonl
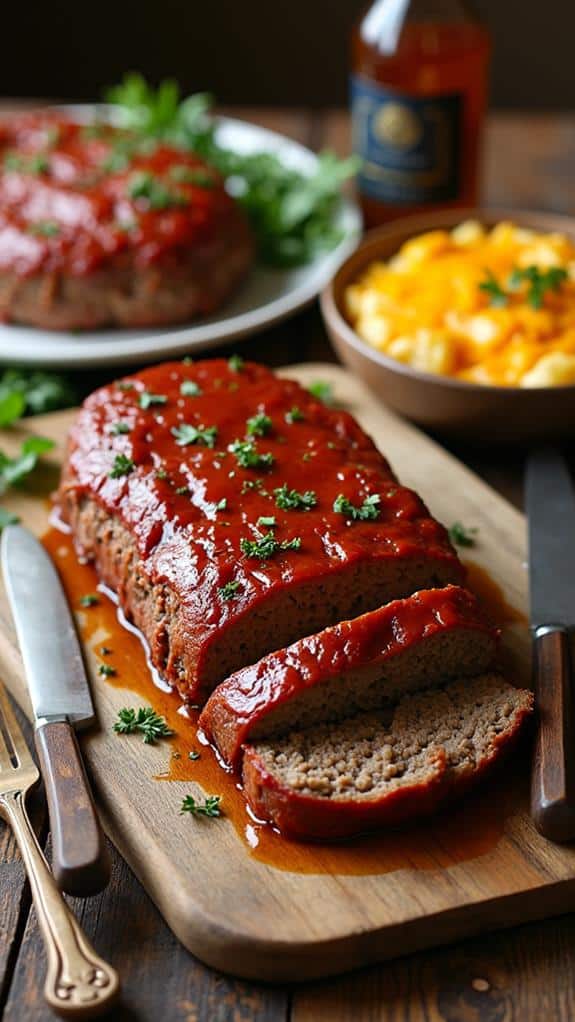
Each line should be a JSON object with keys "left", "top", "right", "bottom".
{"left": 525, "top": 448, "right": 575, "bottom": 842}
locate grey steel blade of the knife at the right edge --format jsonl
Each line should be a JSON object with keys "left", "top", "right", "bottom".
{"left": 525, "top": 448, "right": 575, "bottom": 629}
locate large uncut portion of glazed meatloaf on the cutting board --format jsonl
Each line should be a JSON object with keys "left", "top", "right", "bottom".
{"left": 58, "top": 359, "right": 464, "bottom": 702}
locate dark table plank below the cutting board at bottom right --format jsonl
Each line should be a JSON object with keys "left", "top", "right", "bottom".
{"left": 291, "top": 916, "right": 575, "bottom": 1022}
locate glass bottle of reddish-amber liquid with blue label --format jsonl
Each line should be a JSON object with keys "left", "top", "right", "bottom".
{"left": 351, "top": 0, "right": 490, "bottom": 227}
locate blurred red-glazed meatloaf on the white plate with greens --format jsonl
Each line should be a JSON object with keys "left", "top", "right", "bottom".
{"left": 0, "top": 112, "right": 253, "bottom": 330}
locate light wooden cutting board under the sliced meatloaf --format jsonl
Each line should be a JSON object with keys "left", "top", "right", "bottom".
{"left": 0, "top": 365, "right": 575, "bottom": 981}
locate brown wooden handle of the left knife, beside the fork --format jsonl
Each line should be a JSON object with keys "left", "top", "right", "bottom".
{"left": 35, "top": 721, "right": 110, "bottom": 897}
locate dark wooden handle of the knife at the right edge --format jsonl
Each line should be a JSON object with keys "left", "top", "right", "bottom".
{"left": 531, "top": 626, "right": 575, "bottom": 842}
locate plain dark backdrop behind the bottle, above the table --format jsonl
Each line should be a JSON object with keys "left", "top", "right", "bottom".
{"left": 0, "top": 0, "right": 575, "bottom": 108}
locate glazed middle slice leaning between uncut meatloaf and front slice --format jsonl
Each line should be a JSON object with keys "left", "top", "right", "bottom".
{"left": 199, "top": 586, "right": 497, "bottom": 768}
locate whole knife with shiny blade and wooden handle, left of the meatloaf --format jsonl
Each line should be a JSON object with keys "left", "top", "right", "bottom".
{"left": 1, "top": 525, "right": 109, "bottom": 897}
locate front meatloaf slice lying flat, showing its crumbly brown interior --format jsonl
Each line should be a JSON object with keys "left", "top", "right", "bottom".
{"left": 243, "top": 675, "right": 533, "bottom": 840}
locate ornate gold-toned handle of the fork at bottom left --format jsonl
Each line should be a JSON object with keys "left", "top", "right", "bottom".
{"left": 0, "top": 790, "right": 119, "bottom": 1019}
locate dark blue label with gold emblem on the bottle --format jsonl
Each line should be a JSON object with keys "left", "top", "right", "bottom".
{"left": 351, "top": 76, "right": 463, "bottom": 205}
